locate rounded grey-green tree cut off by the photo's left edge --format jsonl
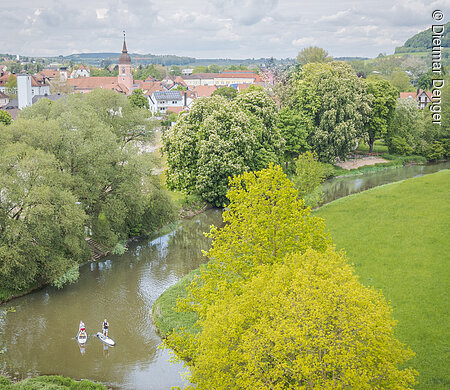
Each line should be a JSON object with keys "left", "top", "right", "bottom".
{"left": 0, "top": 143, "right": 88, "bottom": 291}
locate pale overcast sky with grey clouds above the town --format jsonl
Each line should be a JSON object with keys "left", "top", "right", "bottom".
{"left": 0, "top": 0, "right": 450, "bottom": 58}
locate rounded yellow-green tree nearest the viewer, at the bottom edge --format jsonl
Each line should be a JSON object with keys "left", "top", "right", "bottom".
{"left": 185, "top": 249, "right": 417, "bottom": 390}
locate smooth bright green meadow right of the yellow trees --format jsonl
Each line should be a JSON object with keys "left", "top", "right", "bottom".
{"left": 315, "top": 170, "right": 450, "bottom": 390}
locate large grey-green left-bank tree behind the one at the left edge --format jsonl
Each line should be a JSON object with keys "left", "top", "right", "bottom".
{"left": 3, "top": 90, "right": 176, "bottom": 246}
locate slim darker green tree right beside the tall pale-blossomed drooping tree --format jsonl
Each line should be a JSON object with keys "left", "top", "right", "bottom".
{"left": 366, "top": 79, "right": 398, "bottom": 153}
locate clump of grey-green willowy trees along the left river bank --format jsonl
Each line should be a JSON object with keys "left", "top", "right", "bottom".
{"left": 0, "top": 90, "right": 175, "bottom": 290}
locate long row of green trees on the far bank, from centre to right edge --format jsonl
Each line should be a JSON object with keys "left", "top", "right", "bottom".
{"left": 163, "top": 57, "right": 450, "bottom": 206}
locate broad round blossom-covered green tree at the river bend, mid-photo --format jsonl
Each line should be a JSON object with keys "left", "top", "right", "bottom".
{"left": 163, "top": 88, "right": 283, "bottom": 207}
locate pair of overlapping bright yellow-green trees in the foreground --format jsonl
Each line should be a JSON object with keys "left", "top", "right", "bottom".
{"left": 166, "top": 166, "right": 416, "bottom": 389}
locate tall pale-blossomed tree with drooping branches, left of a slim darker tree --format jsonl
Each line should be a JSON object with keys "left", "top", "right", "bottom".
{"left": 283, "top": 61, "right": 371, "bottom": 162}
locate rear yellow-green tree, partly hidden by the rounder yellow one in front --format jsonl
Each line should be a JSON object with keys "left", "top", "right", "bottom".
{"left": 168, "top": 165, "right": 330, "bottom": 359}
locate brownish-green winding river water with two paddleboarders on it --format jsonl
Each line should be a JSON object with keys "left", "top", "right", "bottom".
{"left": 0, "top": 163, "right": 450, "bottom": 390}
